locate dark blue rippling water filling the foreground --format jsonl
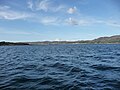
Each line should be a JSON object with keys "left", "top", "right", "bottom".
{"left": 0, "top": 44, "right": 120, "bottom": 90}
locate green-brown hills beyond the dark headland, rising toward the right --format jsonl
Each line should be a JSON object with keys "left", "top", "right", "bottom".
{"left": 29, "top": 35, "right": 120, "bottom": 45}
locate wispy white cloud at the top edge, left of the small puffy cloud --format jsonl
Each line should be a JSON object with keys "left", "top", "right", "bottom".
{"left": 28, "top": 0, "right": 65, "bottom": 12}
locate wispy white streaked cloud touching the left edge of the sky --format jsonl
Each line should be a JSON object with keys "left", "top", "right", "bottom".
{"left": 0, "top": 6, "right": 31, "bottom": 20}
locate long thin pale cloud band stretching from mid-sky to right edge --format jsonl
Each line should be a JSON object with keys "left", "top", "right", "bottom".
{"left": 39, "top": 17, "right": 120, "bottom": 27}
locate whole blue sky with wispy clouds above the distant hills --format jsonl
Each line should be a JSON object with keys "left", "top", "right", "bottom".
{"left": 0, "top": 0, "right": 120, "bottom": 42}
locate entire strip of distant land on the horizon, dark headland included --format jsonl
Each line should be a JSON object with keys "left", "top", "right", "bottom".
{"left": 0, "top": 35, "right": 120, "bottom": 46}
